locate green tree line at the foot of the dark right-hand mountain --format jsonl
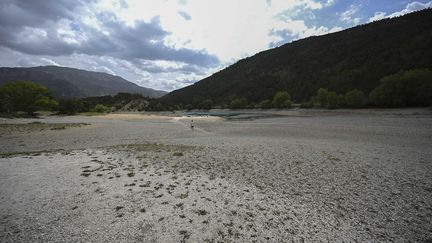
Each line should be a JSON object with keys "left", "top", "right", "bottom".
{"left": 173, "top": 69, "right": 432, "bottom": 109}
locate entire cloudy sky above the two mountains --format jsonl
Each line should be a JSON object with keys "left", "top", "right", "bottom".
{"left": 0, "top": 0, "right": 432, "bottom": 91}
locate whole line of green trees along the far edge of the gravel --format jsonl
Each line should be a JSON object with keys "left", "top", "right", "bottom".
{"left": 0, "top": 69, "right": 432, "bottom": 116}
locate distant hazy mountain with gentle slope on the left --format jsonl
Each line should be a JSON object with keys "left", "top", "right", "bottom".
{"left": 0, "top": 66, "right": 166, "bottom": 98}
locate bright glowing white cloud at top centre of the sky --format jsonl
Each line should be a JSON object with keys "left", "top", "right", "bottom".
{"left": 99, "top": 0, "right": 335, "bottom": 63}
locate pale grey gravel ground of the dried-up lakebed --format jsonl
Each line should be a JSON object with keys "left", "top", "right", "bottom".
{"left": 0, "top": 109, "right": 432, "bottom": 242}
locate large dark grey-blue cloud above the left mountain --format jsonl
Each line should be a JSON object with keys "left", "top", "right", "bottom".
{"left": 0, "top": 0, "right": 219, "bottom": 67}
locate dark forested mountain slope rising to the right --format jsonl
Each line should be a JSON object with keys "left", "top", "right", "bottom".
{"left": 162, "top": 9, "right": 432, "bottom": 105}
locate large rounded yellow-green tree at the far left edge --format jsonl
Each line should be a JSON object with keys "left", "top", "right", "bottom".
{"left": 0, "top": 81, "right": 58, "bottom": 115}
